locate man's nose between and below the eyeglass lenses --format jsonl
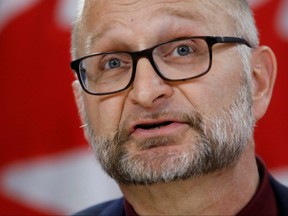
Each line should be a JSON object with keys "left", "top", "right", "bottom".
{"left": 128, "top": 58, "right": 173, "bottom": 108}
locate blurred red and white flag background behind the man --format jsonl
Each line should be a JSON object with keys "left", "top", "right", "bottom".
{"left": 0, "top": 0, "right": 288, "bottom": 215}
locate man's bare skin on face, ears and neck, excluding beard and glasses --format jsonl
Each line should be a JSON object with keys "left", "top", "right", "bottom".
{"left": 73, "top": 0, "right": 276, "bottom": 215}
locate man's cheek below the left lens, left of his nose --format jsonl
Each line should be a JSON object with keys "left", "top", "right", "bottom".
{"left": 84, "top": 95, "right": 123, "bottom": 136}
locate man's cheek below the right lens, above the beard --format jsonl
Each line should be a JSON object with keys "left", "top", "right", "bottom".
{"left": 179, "top": 56, "right": 243, "bottom": 114}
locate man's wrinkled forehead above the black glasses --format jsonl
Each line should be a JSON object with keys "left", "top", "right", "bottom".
{"left": 82, "top": 0, "right": 232, "bottom": 53}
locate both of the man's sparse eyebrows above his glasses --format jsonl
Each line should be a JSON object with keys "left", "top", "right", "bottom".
{"left": 85, "top": 3, "right": 207, "bottom": 54}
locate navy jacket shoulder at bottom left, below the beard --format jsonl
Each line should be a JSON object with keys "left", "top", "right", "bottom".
{"left": 74, "top": 198, "right": 125, "bottom": 216}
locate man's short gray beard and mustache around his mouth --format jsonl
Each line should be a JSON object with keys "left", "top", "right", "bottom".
{"left": 86, "top": 77, "right": 255, "bottom": 185}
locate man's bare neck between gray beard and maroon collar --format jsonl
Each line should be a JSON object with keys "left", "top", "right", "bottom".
{"left": 120, "top": 143, "right": 259, "bottom": 215}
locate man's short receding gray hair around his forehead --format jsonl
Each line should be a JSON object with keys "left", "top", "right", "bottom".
{"left": 71, "top": 0, "right": 259, "bottom": 59}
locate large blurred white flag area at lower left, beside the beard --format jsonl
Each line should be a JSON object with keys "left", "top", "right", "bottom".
{"left": 0, "top": 147, "right": 121, "bottom": 214}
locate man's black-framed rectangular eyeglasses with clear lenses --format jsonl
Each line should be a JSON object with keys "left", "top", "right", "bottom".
{"left": 71, "top": 36, "right": 251, "bottom": 95}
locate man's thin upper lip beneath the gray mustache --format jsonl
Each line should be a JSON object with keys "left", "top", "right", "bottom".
{"left": 129, "top": 118, "right": 183, "bottom": 134}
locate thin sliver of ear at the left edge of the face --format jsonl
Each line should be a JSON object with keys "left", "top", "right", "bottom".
{"left": 72, "top": 80, "right": 88, "bottom": 139}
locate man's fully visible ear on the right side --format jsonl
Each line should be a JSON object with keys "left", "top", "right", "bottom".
{"left": 251, "top": 46, "right": 277, "bottom": 120}
